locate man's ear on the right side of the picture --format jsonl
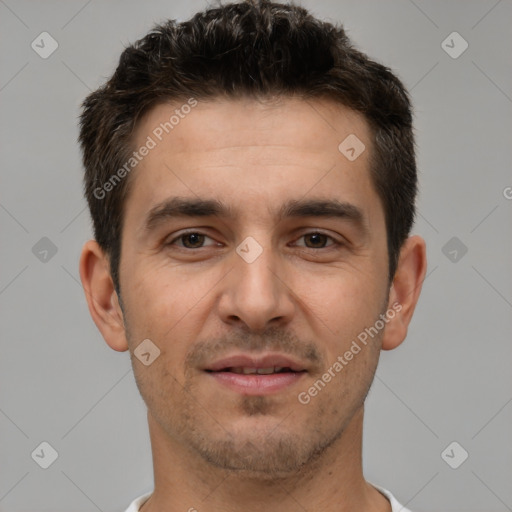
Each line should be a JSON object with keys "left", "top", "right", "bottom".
{"left": 382, "top": 236, "right": 427, "bottom": 350}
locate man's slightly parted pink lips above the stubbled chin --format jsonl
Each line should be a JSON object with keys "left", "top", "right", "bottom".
{"left": 203, "top": 354, "right": 307, "bottom": 396}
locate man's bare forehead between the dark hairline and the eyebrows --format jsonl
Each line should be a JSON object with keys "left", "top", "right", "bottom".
{"left": 123, "top": 98, "right": 379, "bottom": 230}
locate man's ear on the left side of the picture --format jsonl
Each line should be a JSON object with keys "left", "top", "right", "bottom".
{"left": 80, "top": 240, "right": 128, "bottom": 352}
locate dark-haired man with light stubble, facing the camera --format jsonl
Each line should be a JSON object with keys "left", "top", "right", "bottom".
{"left": 80, "top": 1, "right": 426, "bottom": 512}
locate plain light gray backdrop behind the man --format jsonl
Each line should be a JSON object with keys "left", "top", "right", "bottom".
{"left": 0, "top": 0, "right": 512, "bottom": 512}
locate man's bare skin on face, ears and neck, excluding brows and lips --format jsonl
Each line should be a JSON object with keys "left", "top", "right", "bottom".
{"left": 80, "top": 98, "right": 426, "bottom": 512}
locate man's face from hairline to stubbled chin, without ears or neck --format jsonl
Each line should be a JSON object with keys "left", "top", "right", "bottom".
{"left": 120, "top": 99, "right": 389, "bottom": 477}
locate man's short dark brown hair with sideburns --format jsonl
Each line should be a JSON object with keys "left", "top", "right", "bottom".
{"left": 79, "top": 0, "right": 417, "bottom": 293}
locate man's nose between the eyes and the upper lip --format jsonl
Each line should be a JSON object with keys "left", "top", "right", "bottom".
{"left": 218, "top": 240, "right": 295, "bottom": 331}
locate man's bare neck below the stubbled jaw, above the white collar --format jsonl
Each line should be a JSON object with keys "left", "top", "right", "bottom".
{"left": 141, "top": 407, "right": 391, "bottom": 512}
